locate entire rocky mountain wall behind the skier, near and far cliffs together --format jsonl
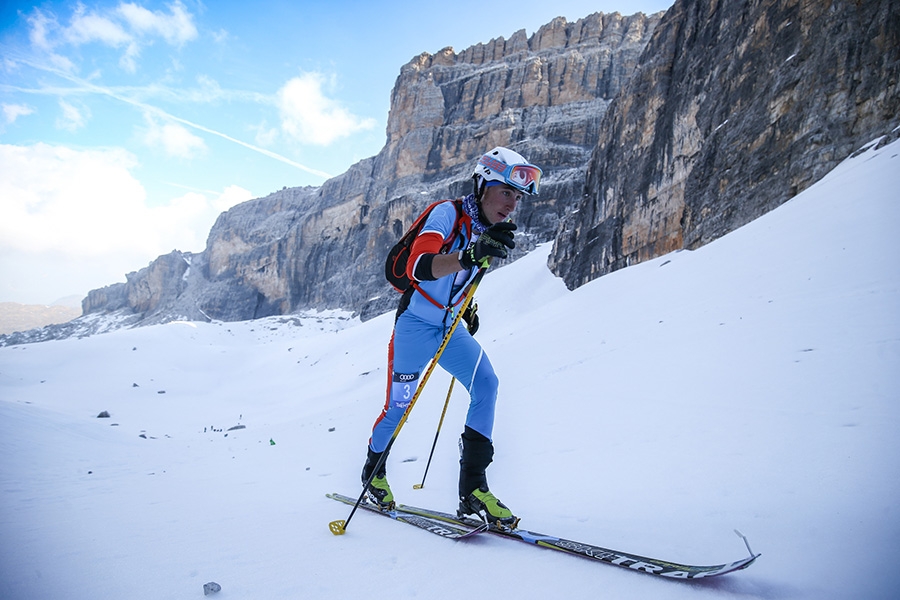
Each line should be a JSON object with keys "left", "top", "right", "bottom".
{"left": 5, "top": 0, "right": 900, "bottom": 343}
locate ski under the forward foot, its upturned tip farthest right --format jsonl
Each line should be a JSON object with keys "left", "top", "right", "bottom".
{"left": 397, "top": 504, "right": 760, "bottom": 579}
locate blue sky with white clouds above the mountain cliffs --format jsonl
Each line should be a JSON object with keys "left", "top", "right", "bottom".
{"left": 0, "top": 0, "right": 672, "bottom": 304}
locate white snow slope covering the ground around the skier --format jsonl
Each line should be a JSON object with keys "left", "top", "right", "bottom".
{"left": 0, "top": 137, "right": 900, "bottom": 600}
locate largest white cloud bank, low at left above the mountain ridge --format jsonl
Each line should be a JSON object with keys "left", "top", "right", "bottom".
{"left": 0, "top": 144, "right": 251, "bottom": 303}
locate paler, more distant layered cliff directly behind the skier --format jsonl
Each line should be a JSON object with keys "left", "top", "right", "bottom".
{"left": 75, "top": 13, "right": 662, "bottom": 324}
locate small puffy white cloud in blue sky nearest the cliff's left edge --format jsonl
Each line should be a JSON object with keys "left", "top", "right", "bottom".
{"left": 278, "top": 73, "right": 375, "bottom": 146}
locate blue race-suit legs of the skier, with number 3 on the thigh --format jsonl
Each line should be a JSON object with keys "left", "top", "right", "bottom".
{"left": 369, "top": 311, "right": 499, "bottom": 452}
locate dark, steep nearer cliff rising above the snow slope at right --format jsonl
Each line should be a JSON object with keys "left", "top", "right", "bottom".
{"left": 550, "top": 0, "right": 900, "bottom": 288}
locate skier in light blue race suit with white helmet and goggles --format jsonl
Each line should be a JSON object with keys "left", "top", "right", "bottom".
{"left": 362, "top": 147, "right": 541, "bottom": 526}
